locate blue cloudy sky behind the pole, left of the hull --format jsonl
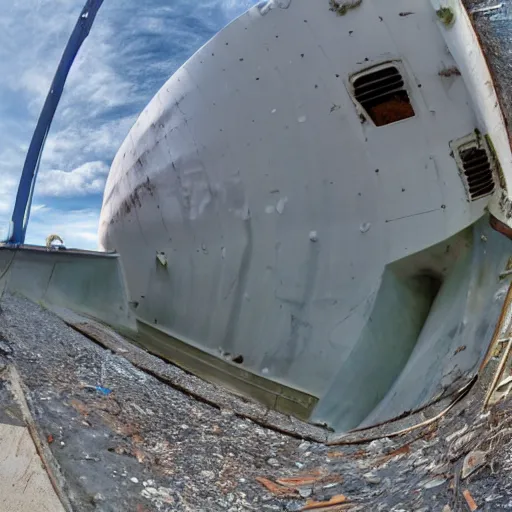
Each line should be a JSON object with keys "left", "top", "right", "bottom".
{"left": 0, "top": 0, "right": 254, "bottom": 249}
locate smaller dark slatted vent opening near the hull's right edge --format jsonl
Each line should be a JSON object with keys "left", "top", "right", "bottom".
{"left": 459, "top": 147, "right": 494, "bottom": 201}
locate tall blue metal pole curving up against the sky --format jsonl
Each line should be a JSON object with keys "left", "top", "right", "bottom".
{"left": 7, "top": 0, "right": 103, "bottom": 245}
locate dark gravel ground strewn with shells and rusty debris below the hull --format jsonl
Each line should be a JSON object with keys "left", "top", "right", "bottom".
{"left": 0, "top": 296, "right": 512, "bottom": 512}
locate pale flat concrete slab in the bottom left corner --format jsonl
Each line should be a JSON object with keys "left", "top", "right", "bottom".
{"left": 0, "top": 423, "right": 64, "bottom": 512}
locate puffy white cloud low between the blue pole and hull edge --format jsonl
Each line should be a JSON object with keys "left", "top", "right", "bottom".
{"left": 36, "top": 162, "right": 108, "bottom": 197}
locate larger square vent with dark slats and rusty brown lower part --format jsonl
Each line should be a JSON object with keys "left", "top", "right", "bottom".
{"left": 352, "top": 66, "right": 414, "bottom": 126}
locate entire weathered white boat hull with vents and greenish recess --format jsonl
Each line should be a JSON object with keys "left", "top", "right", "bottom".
{"left": 100, "top": 0, "right": 512, "bottom": 430}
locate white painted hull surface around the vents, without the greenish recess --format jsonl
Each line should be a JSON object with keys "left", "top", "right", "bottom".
{"left": 100, "top": 0, "right": 508, "bottom": 428}
